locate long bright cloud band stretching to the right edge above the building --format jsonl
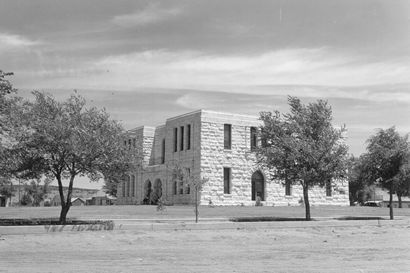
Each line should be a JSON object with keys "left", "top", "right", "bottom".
{"left": 85, "top": 48, "right": 410, "bottom": 101}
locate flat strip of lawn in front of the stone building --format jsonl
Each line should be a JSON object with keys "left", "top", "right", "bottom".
{"left": 0, "top": 205, "right": 410, "bottom": 219}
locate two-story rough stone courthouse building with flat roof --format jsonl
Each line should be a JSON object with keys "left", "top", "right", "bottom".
{"left": 117, "top": 110, "right": 349, "bottom": 206}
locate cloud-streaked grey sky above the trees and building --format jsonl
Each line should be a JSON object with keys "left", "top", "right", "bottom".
{"left": 0, "top": 0, "right": 410, "bottom": 187}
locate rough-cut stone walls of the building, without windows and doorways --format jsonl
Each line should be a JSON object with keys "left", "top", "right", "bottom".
{"left": 117, "top": 110, "right": 349, "bottom": 206}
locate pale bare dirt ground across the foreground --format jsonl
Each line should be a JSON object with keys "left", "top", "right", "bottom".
{"left": 0, "top": 222, "right": 410, "bottom": 273}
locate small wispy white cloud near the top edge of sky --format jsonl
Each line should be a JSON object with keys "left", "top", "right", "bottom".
{"left": 112, "top": 4, "right": 181, "bottom": 27}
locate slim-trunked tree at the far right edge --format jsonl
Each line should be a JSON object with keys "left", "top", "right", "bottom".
{"left": 364, "top": 127, "right": 410, "bottom": 220}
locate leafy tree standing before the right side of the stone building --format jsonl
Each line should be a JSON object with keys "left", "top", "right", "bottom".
{"left": 257, "top": 97, "right": 347, "bottom": 220}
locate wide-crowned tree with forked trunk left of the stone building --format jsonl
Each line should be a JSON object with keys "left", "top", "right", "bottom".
{"left": 12, "top": 92, "right": 128, "bottom": 224}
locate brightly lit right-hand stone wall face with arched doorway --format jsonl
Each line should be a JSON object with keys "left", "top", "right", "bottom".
{"left": 201, "top": 111, "right": 349, "bottom": 206}
